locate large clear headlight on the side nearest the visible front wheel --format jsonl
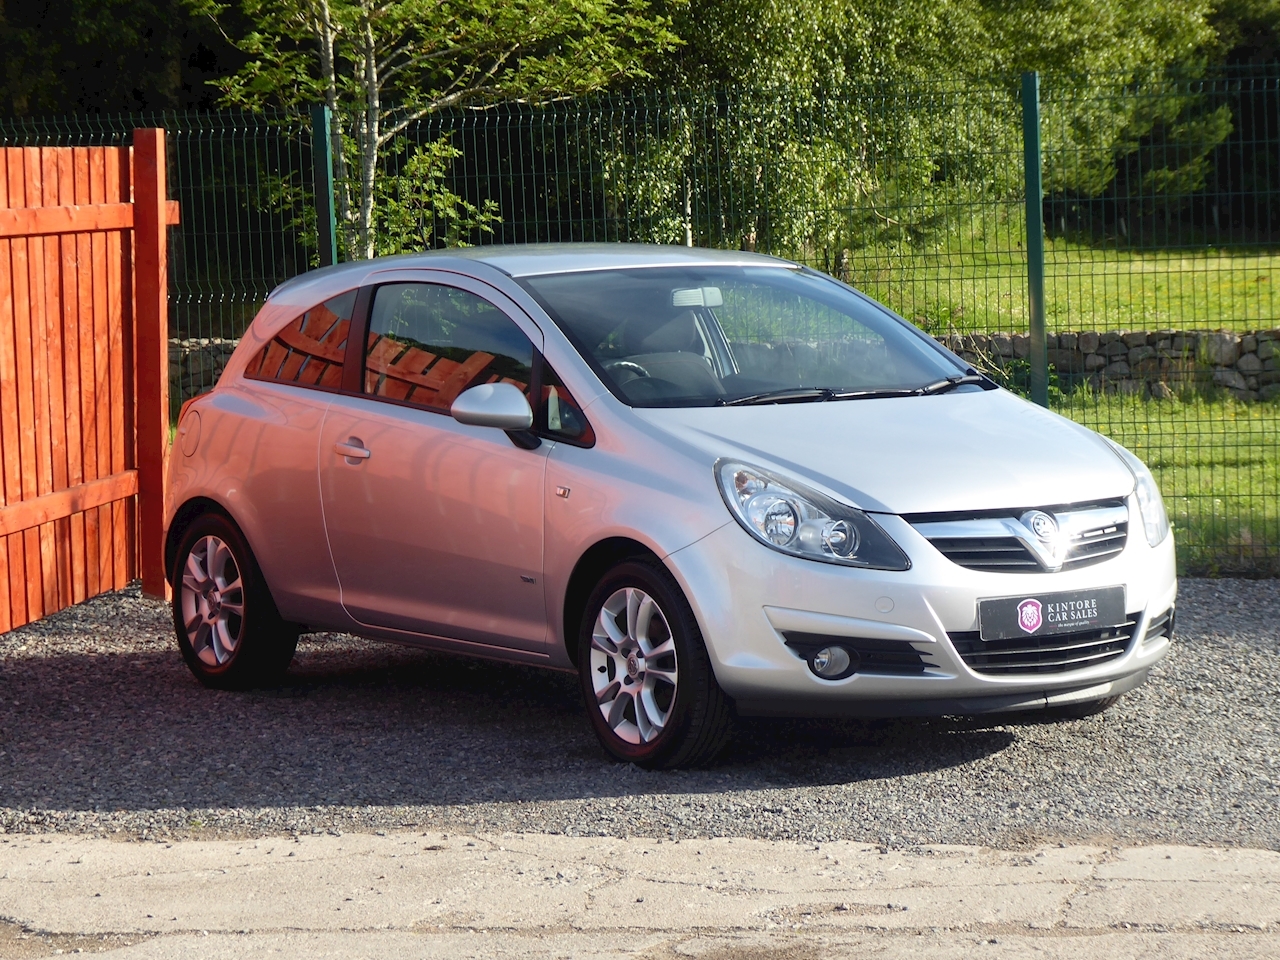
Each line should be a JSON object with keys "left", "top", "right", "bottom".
{"left": 716, "top": 460, "right": 911, "bottom": 570}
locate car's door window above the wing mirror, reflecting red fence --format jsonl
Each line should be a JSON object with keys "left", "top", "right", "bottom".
{"left": 365, "top": 283, "right": 534, "bottom": 412}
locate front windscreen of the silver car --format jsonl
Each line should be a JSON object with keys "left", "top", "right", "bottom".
{"left": 522, "top": 266, "right": 972, "bottom": 407}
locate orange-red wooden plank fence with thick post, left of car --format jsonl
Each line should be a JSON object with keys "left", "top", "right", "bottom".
{"left": 0, "top": 129, "right": 178, "bottom": 632}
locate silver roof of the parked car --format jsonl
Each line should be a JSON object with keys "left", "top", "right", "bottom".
{"left": 271, "top": 243, "right": 794, "bottom": 298}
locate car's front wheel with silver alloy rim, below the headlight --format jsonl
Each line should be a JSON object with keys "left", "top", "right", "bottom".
{"left": 577, "top": 561, "right": 732, "bottom": 768}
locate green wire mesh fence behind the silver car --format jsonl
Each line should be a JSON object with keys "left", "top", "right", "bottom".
{"left": 0, "top": 67, "right": 1280, "bottom": 575}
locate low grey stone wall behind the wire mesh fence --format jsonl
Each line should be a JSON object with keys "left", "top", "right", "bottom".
{"left": 169, "top": 330, "right": 1280, "bottom": 402}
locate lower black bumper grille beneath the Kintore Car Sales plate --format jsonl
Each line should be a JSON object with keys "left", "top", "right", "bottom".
{"left": 950, "top": 613, "right": 1138, "bottom": 676}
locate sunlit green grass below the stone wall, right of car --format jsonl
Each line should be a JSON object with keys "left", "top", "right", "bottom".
{"left": 1059, "top": 393, "right": 1280, "bottom": 576}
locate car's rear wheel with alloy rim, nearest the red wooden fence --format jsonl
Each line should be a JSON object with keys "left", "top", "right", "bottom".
{"left": 173, "top": 513, "right": 298, "bottom": 690}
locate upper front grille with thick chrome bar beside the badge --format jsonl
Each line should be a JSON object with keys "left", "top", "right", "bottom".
{"left": 905, "top": 500, "right": 1129, "bottom": 573}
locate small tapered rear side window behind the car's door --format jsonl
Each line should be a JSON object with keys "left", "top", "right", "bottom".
{"left": 244, "top": 291, "right": 356, "bottom": 389}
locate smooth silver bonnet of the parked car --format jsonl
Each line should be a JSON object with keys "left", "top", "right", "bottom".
{"left": 636, "top": 390, "right": 1134, "bottom": 513}
